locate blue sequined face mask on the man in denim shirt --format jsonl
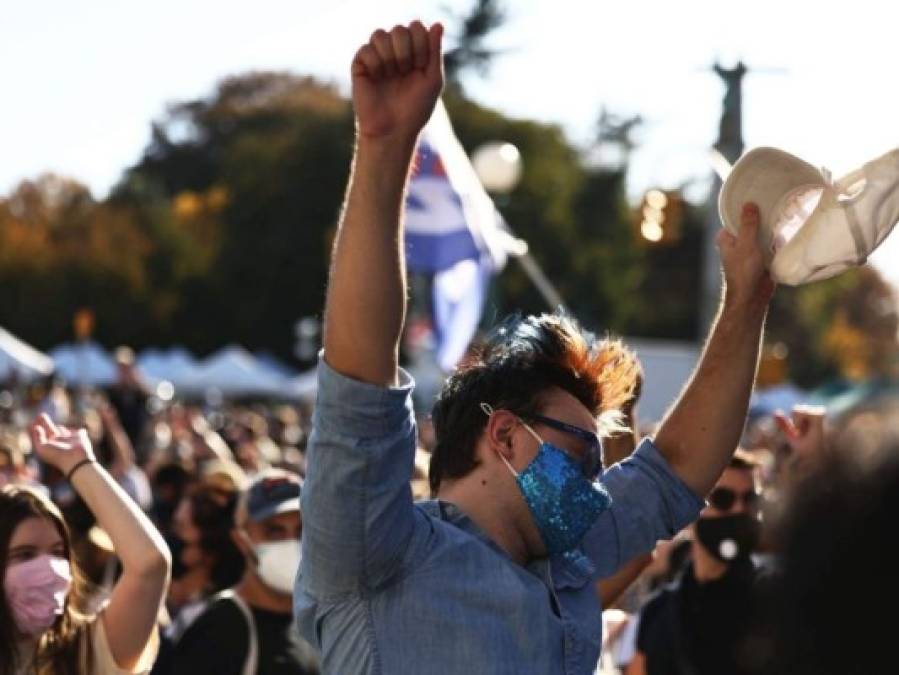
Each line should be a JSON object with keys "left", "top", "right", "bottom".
{"left": 481, "top": 403, "right": 612, "bottom": 557}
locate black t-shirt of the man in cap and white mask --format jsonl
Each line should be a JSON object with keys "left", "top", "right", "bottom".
{"left": 172, "top": 599, "right": 319, "bottom": 675}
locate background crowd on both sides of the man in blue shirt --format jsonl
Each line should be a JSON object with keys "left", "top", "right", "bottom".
{"left": 0, "top": 340, "right": 899, "bottom": 675}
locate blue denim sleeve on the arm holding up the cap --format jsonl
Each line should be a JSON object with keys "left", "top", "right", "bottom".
{"left": 581, "top": 438, "right": 705, "bottom": 577}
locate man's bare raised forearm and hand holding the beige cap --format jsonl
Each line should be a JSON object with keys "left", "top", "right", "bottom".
{"left": 655, "top": 204, "right": 774, "bottom": 496}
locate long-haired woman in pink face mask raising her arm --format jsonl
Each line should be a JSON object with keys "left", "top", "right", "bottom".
{"left": 0, "top": 415, "right": 171, "bottom": 675}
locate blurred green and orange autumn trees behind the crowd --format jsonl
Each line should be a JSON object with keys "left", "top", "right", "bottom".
{"left": 0, "top": 72, "right": 895, "bottom": 383}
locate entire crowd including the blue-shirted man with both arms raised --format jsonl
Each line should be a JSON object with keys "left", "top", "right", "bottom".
{"left": 0, "top": 14, "right": 899, "bottom": 675}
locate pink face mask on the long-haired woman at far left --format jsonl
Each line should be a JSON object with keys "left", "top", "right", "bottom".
{"left": 3, "top": 555, "right": 72, "bottom": 636}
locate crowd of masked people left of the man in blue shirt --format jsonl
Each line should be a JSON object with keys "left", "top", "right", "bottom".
{"left": 0, "top": 350, "right": 319, "bottom": 675}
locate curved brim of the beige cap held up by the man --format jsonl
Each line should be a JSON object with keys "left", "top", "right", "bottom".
{"left": 718, "top": 147, "right": 824, "bottom": 264}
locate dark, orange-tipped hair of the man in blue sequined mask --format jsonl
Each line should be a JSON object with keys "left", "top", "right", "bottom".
{"left": 429, "top": 312, "right": 641, "bottom": 492}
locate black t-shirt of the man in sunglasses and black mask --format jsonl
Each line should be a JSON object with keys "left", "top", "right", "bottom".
{"left": 637, "top": 561, "right": 759, "bottom": 675}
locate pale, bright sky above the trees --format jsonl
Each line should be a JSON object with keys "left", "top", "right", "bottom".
{"left": 0, "top": 0, "right": 899, "bottom": 280}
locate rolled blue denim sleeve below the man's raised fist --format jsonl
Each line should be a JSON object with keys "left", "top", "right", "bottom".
{"left": 297, "top": 358, "right": 416, "bottom": 600}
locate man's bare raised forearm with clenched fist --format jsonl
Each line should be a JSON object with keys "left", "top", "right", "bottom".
{"left": 324, "top": 21, "right": 443, "bottom": 386}
